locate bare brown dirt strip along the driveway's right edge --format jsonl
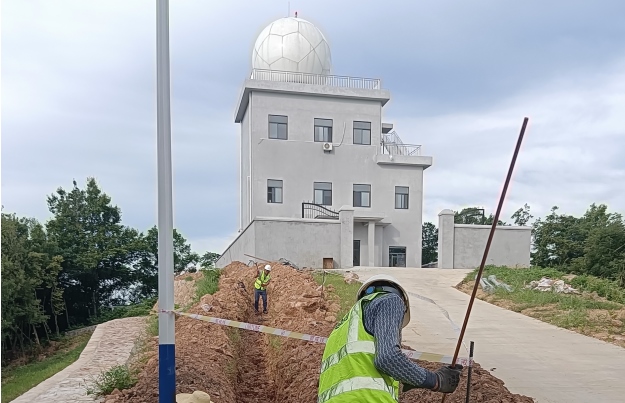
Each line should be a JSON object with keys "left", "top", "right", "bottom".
{"left": 456, "top": 281, "right": 625, "bottom": 348}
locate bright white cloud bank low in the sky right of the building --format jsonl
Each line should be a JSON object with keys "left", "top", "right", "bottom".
{"left": 395, "top": 60, "right": 625, "bottom": 226}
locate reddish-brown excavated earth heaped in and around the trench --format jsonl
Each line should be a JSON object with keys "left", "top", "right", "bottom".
{"left": 111, "top": 262, "right": 533, "bottom": 403}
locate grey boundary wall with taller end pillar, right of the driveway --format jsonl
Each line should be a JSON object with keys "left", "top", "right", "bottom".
{"left": 438, "top": 210, "right": 532, "bottom": 269}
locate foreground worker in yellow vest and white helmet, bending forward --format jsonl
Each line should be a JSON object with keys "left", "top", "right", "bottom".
{"left": 317, "top": 274, "right": 462, "bottom": 403}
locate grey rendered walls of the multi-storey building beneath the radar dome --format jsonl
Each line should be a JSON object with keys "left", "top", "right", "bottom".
{"left": 237, "top": 84, "right": 432, "bottom": 267}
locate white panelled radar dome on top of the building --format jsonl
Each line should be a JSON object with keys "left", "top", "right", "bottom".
{"left": 252, "top": 17, "right": 332, "bottom": 75}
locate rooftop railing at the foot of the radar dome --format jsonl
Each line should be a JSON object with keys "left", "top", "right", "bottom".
{"left": 251, "top": 69, "right": 382, "bottom": 90}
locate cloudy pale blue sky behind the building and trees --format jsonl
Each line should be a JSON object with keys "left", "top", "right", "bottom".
{"left": 2, "top": 0, "right": 625, "bottom": 252}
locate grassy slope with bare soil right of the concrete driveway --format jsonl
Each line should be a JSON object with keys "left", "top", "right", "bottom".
{"left": 459, "top": 266, "right": 625, "bottom": 347}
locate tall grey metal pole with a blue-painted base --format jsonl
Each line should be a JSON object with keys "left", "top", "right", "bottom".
{"left": 156, "top": 0, "right": 176, "bottom": 403}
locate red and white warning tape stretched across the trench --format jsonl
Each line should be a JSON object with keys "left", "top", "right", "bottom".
{"left": 160, "top": 310, "right": 473, "bottom": 366}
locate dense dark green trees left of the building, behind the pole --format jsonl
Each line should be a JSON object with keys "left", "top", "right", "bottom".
{"left": 2, "top": 178, "right": 219, "bottom": 362}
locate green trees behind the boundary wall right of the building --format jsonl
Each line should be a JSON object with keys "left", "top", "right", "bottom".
{"left": 422, "top": 203, "right": 625, "bottom": 287}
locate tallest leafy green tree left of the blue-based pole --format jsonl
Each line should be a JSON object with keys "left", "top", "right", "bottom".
{"left": 46, "top": 178, "right": 138, "bottom": 321}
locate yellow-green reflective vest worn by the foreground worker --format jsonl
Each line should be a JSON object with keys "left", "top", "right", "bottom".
{"left": 317, "top": 293, "right": 399, "bottom": 403}
